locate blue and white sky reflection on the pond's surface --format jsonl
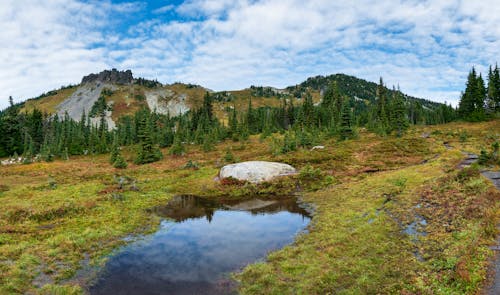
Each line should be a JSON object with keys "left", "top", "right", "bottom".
{"left": 96, "top": 211, "right": 309, "bottom": 284}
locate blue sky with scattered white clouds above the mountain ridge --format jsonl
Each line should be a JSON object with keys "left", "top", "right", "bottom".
{"left": 0, "top": 0, "right": 500, "bottom": 109}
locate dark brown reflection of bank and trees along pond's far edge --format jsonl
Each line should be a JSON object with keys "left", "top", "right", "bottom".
{"left": 153, "top": 195, "right": 309, "bottom": 222}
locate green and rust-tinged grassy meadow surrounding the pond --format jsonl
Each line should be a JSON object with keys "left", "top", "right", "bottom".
{"left": 0, "top": 121, "right": 500, "bottom": 294}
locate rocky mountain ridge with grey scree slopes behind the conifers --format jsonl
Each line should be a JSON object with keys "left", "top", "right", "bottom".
{"left": 17, "top": 69, "right": 440, "bottom": 128}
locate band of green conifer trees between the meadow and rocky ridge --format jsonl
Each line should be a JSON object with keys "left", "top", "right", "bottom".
{"left": 0, "top": 67, "right": 492, "bottom": 168}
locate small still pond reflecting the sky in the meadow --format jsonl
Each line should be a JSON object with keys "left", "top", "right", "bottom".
{"left": 89, "top": 196, "right": 310, "bottom": 294}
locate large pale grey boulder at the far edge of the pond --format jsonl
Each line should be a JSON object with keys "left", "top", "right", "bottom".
{"left": 219, "top": 161, "right": 297, "bottom": 183}
